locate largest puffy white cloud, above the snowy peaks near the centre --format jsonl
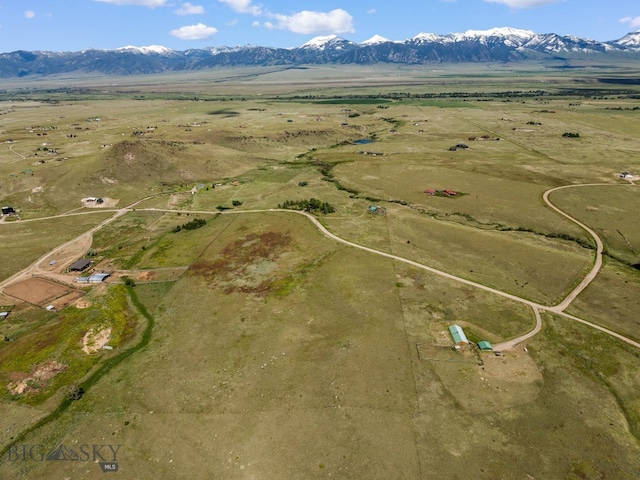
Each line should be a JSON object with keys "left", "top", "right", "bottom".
{"left": 271, "top": 8, "right": 355, "bottom": 34}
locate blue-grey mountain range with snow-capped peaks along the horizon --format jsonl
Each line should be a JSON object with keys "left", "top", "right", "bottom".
{"left": 0, "top": 27, "right": 640, "bottom": 78}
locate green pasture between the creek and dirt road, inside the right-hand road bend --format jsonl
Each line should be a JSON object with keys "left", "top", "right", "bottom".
{"left": 338, "top": 206, "right": 593, "bottom": 304}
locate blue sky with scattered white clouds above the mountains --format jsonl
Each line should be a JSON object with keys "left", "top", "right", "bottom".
{"left": 0, "top": 0, "right": 640, "bottom": 52}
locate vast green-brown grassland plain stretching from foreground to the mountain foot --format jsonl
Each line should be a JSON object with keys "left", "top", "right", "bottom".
{"left": 0, "top": 64, "right": 640, "bottom": 480}
